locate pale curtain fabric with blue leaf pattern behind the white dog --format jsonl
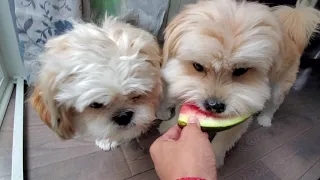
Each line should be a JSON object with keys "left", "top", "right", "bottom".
{"left": 15, "top": 0, "right": 82, "bottom": 83}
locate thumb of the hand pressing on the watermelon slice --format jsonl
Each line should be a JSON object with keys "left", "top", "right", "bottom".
{"left": 180, "top": 117, "right": 203, "bottom": 140}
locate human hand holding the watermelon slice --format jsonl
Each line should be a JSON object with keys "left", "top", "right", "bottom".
{"left": 150, "top": 117, "right": 217, "bottom": 180}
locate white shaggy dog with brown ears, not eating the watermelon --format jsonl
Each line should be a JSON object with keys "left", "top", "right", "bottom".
{"left": 31, "top": 17, "right": 162, "bottom": 150}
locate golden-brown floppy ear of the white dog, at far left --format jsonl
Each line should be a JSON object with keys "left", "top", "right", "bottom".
{"left": 30, "top": 86, "right": 74, "bottom": 139}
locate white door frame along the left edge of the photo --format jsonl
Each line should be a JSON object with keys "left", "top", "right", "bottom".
{"left": 0, "top": 0, "right": 26, "bottom": 180}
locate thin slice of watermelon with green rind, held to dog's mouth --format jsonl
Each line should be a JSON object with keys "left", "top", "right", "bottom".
{"left": 178, "top": 104, "right": 251, "bottom": 132}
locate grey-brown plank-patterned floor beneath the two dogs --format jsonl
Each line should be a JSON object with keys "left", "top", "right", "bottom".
{"left": 0, "top": 73, "right": 320, "bottom": 180}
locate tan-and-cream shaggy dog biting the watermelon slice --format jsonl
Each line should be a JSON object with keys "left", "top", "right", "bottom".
{"left": 159, "top": 0, "right": 320, "bottom": 166}
